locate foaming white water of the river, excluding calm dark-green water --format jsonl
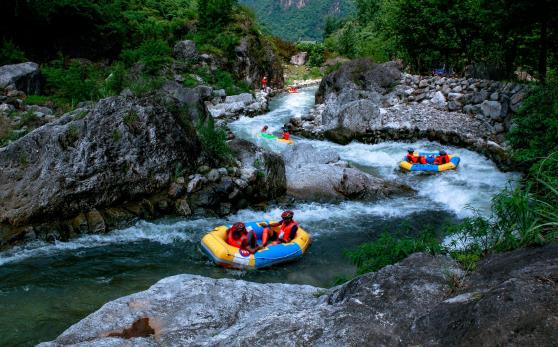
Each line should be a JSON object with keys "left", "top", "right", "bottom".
{"left": 0, "top": 87, "right": 518, "bottom": 267}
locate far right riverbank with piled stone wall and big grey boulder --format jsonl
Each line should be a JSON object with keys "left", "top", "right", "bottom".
{"left": 288, "top": 60, "right": 528, "bottom": 169}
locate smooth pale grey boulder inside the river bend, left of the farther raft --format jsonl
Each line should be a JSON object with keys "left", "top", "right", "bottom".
{"left": 282, "top": 143, "right": 412, "bottom": 201}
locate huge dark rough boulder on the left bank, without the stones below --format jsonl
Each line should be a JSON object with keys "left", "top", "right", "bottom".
{"left": 0, "top": 95, "right": 200, "bottom": 231}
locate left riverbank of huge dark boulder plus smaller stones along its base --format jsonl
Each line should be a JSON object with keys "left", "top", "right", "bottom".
{"left": 0, "top": 82, "right": 286, "bottom": 247}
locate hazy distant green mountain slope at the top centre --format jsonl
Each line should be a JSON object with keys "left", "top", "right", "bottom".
{"left": 240, "top": 0, "right": 354, "bottom": 41}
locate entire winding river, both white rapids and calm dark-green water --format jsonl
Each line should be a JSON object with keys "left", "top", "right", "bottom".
{"left": 0, "top": 87, "right": 517, "bottom": 346}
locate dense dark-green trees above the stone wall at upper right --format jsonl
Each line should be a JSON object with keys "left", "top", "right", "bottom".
{"left": 325, "top": 0, "right": 558, "bottom": 80}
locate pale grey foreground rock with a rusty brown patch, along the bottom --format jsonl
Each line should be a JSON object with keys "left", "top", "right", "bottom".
{"left": 40, "top": 244, "right": 558, "bottom": 347}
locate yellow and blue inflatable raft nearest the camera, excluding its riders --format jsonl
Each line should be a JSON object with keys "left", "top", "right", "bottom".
{"left": 201, "top": 221, "right": 311, "bottom": 269}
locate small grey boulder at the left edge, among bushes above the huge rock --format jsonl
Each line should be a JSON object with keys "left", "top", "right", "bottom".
{"left": 0, "top": 62, "right": 41, "bottom": 95}
